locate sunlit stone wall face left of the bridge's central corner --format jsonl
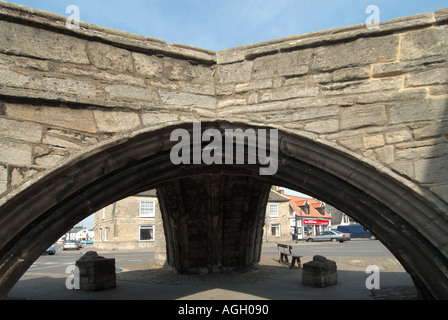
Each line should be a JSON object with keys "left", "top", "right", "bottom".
{"left": 0, "top": 3, "right": 216, "bottom": 200}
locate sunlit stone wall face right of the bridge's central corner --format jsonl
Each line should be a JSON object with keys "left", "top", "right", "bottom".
{"left": 216, "top": 10, "right": 448, "bottom": 200}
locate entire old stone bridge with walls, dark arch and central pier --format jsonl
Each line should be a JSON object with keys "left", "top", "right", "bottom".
{"left": 0, "top": 3, "right": 448, "bottom": 299}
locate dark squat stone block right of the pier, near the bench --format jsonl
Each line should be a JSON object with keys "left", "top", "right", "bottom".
{"left": 302, "top": 255, "right": 338, "bottom": 288}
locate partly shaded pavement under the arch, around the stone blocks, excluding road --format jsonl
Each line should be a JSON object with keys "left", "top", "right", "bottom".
{"left": 6, "top": 241, "right": 417, "bottom": 301}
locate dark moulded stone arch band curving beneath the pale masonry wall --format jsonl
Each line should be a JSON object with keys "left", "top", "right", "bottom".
{"left": 0, "top": 121, "right": 448, "bottom": 299}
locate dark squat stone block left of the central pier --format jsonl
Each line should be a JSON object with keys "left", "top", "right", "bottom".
{"left": 76, "top": 251, "right": 116, "bottom": 291}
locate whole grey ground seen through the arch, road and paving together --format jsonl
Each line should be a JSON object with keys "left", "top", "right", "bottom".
{"left": 9, "top": 240, "right": 416, "bottom": 300}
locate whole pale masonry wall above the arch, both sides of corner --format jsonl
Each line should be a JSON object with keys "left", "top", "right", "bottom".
{"left": 0, "top": 4, "right": 448, "bottom": 200}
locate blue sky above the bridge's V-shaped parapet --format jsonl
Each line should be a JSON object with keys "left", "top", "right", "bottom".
{"left": 7, "top": 0, "right": 448, "bottom": 50}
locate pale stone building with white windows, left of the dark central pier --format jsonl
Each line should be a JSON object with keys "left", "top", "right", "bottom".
{"left": 94, "top": 189, "right": 165, "bottom": 250}
